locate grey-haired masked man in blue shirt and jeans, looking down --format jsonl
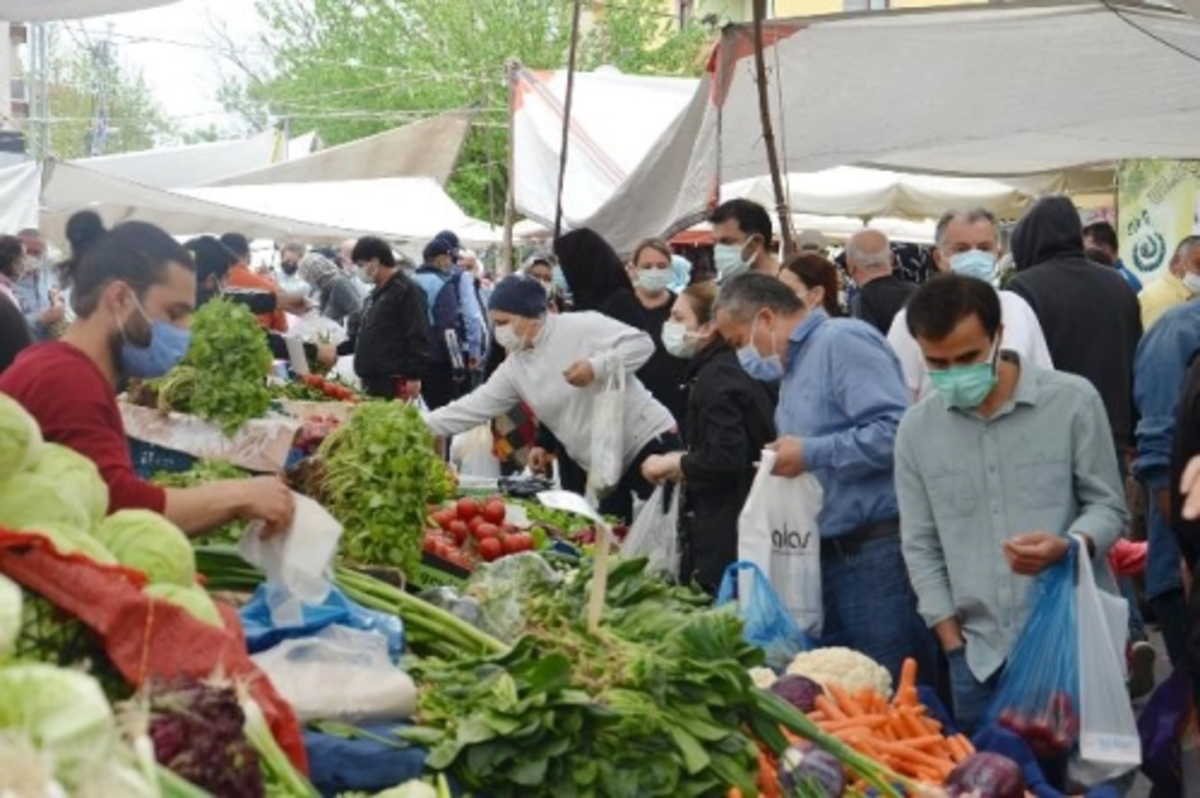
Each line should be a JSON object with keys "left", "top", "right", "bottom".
{"left": 716, "top": 275, "right": 935, "bottom": 677}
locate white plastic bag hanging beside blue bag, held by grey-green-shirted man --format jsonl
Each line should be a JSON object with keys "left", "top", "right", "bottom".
{"left": 1068, "top": 539, "right": 1141, "bottom": 787}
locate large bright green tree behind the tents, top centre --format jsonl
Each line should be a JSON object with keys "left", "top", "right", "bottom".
{"left": 234, "top": 0, "right": 709, "bottom": 221}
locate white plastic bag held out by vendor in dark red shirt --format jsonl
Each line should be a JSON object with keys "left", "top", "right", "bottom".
{"left": 238, "top": 493, "right": 342, "bottom": 626}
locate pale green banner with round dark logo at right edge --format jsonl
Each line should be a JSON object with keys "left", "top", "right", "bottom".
{"left": 1117, "top": 160, "right": 1200, "bottom": 283}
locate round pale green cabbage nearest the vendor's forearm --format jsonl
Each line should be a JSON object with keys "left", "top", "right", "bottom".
{"left": 94, "top": 510, "right": 196, "bottom": 587}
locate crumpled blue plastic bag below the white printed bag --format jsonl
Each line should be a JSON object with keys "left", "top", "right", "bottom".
{"left": 716, "top": 560, "right": 812, "bottom": 671}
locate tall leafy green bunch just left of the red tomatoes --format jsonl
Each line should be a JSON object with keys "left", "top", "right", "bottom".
{"left": 317, "top": 402, "right": 452, "bottom": 576}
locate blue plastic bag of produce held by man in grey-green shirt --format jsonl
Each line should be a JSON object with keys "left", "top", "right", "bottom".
{"left": 988, "top": 541, "right": 1080, "bottom": 760}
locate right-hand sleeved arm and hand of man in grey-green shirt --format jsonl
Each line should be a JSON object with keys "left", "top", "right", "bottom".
{"left": 1069, "top": 385, "right": 1128, "bottom": 562}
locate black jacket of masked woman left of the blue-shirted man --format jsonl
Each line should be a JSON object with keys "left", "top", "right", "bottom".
{"left": 679, "top": 341, "right": 775, "bottom": 594}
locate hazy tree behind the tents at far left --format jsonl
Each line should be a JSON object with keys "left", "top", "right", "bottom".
{"left": 49, "top": 35, "right": 172, "bottom": 160}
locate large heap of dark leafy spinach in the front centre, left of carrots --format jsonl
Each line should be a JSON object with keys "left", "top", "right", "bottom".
{"left": 403, "top": 559, "right": 762, "bottom": 798}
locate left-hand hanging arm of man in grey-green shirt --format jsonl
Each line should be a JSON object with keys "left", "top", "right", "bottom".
{"left": 895, "top": 424, "right": 964, "bottom": 652}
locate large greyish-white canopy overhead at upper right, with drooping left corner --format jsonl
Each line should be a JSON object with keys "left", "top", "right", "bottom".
{"left": 574, "top": 0, "right": 1200, "bottom": 248}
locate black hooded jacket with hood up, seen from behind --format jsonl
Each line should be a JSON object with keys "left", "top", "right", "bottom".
{"left": 1009, "top": 197, "right": 1141, "bottom": 449}
